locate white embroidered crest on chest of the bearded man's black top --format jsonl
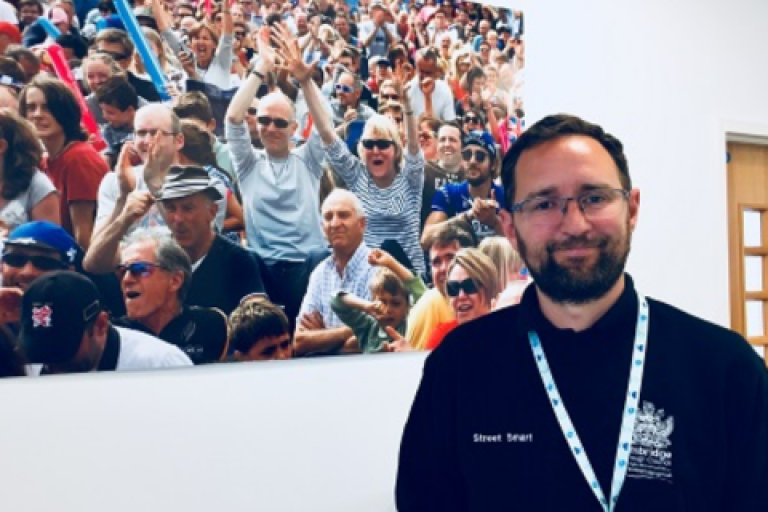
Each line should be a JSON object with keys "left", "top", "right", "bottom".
{"left": 627, "top": 401, "right": 675, "bottom": 483}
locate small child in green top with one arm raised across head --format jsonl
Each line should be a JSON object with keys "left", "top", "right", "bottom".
{"left": 331, "top": 249, "right": 426, "bottom": 354}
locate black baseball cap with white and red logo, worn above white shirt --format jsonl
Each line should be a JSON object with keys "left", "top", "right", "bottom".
{"left": 20, "top": 270, "right": 101, "bottom": 364}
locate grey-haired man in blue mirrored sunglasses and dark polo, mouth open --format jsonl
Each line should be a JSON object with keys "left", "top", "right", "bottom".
{"left": 114, "top": 228, "right": 229, "bottom": 365}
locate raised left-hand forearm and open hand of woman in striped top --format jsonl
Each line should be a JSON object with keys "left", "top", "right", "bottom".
{"left": 272, "top": 25, "right": 336, "bottom": 147}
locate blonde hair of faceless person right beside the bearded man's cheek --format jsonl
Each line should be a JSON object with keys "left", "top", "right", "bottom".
{"left": 477, "top": 236, "right": 529, "bottom": 310}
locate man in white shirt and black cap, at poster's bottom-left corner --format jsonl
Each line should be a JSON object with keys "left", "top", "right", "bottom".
{"left": 20, "top": 271, "right": 192, "bottom": 375}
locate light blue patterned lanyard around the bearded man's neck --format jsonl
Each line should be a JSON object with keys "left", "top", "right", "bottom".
{"left": 528, "top": 294, "right": 649, "bottom": 512}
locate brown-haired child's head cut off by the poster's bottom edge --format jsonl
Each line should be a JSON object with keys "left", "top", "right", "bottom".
{"left": 229, "top": 296, "right": 293, "bottom": 361}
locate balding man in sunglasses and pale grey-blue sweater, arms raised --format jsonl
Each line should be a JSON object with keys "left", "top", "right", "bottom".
{"left": 225, "top": 30, "right": 331, "bottom": 330}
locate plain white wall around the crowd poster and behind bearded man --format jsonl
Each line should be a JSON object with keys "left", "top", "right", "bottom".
{"left": 0, "top": 0, "right": 768, "bottom": 512}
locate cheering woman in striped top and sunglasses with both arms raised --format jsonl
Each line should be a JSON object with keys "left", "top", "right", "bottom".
{"left": 274, "top": 23, "right": 425, "bottom": 280}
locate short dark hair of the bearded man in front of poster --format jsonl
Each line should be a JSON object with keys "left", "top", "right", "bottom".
{"left": 501, "top": 114, "right": 632, "bottom": 209}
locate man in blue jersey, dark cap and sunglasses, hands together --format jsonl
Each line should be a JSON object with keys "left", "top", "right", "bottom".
{"left": 421, "top": 131, "right": 504, "bottom": 250}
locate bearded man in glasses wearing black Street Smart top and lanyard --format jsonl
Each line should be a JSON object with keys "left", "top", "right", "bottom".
{"left": 396, "top": 115, "right": 768, "bottom": 512}
